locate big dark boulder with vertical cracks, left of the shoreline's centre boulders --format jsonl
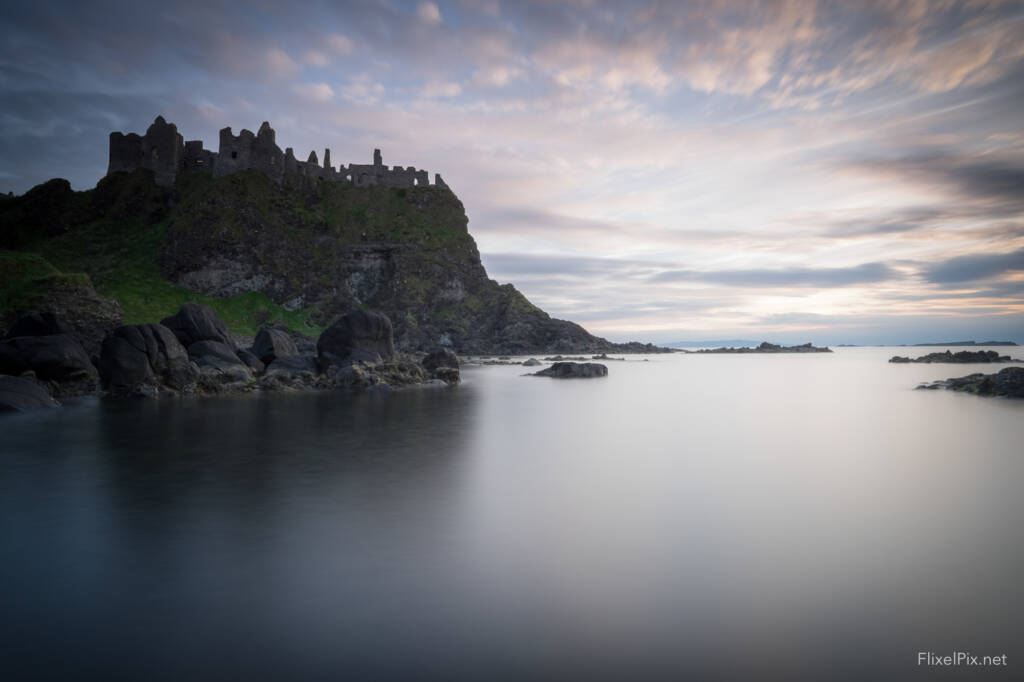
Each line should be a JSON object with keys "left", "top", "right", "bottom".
{"left": 99, "top": 325, "right": 199, "bottom": 394}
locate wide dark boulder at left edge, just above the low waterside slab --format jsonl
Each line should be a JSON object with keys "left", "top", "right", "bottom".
{"left": 0, "top": 334, "right": 97, "bottom": 382}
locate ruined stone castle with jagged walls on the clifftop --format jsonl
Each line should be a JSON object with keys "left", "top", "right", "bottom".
{"left": 106, "top": 116, "right": 447, "bottom": 187}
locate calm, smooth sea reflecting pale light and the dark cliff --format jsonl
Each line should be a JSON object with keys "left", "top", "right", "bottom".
{"left": 0, "top": 348, "right": 1024, "bottom": 680}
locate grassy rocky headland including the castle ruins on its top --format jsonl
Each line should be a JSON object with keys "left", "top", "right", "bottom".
{"left": 0, "top": 118, "right": 662, "bottom": 364}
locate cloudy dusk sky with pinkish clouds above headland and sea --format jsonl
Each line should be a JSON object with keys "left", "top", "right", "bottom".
{"left": 0, "top": 0, "right": 1024, "bottom": 344}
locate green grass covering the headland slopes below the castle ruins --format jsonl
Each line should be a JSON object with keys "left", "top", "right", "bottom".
{"left": 0, "top": 166, "right": 477, "bottom": 336}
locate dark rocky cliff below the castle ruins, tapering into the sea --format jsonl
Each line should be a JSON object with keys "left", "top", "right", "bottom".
{"left": 0, "top": 169, "right": 630, "bottom": 353}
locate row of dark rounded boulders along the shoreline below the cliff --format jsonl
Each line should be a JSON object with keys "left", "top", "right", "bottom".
{"left": 0, "top": 303, "right": 460, "bottom": 411}
